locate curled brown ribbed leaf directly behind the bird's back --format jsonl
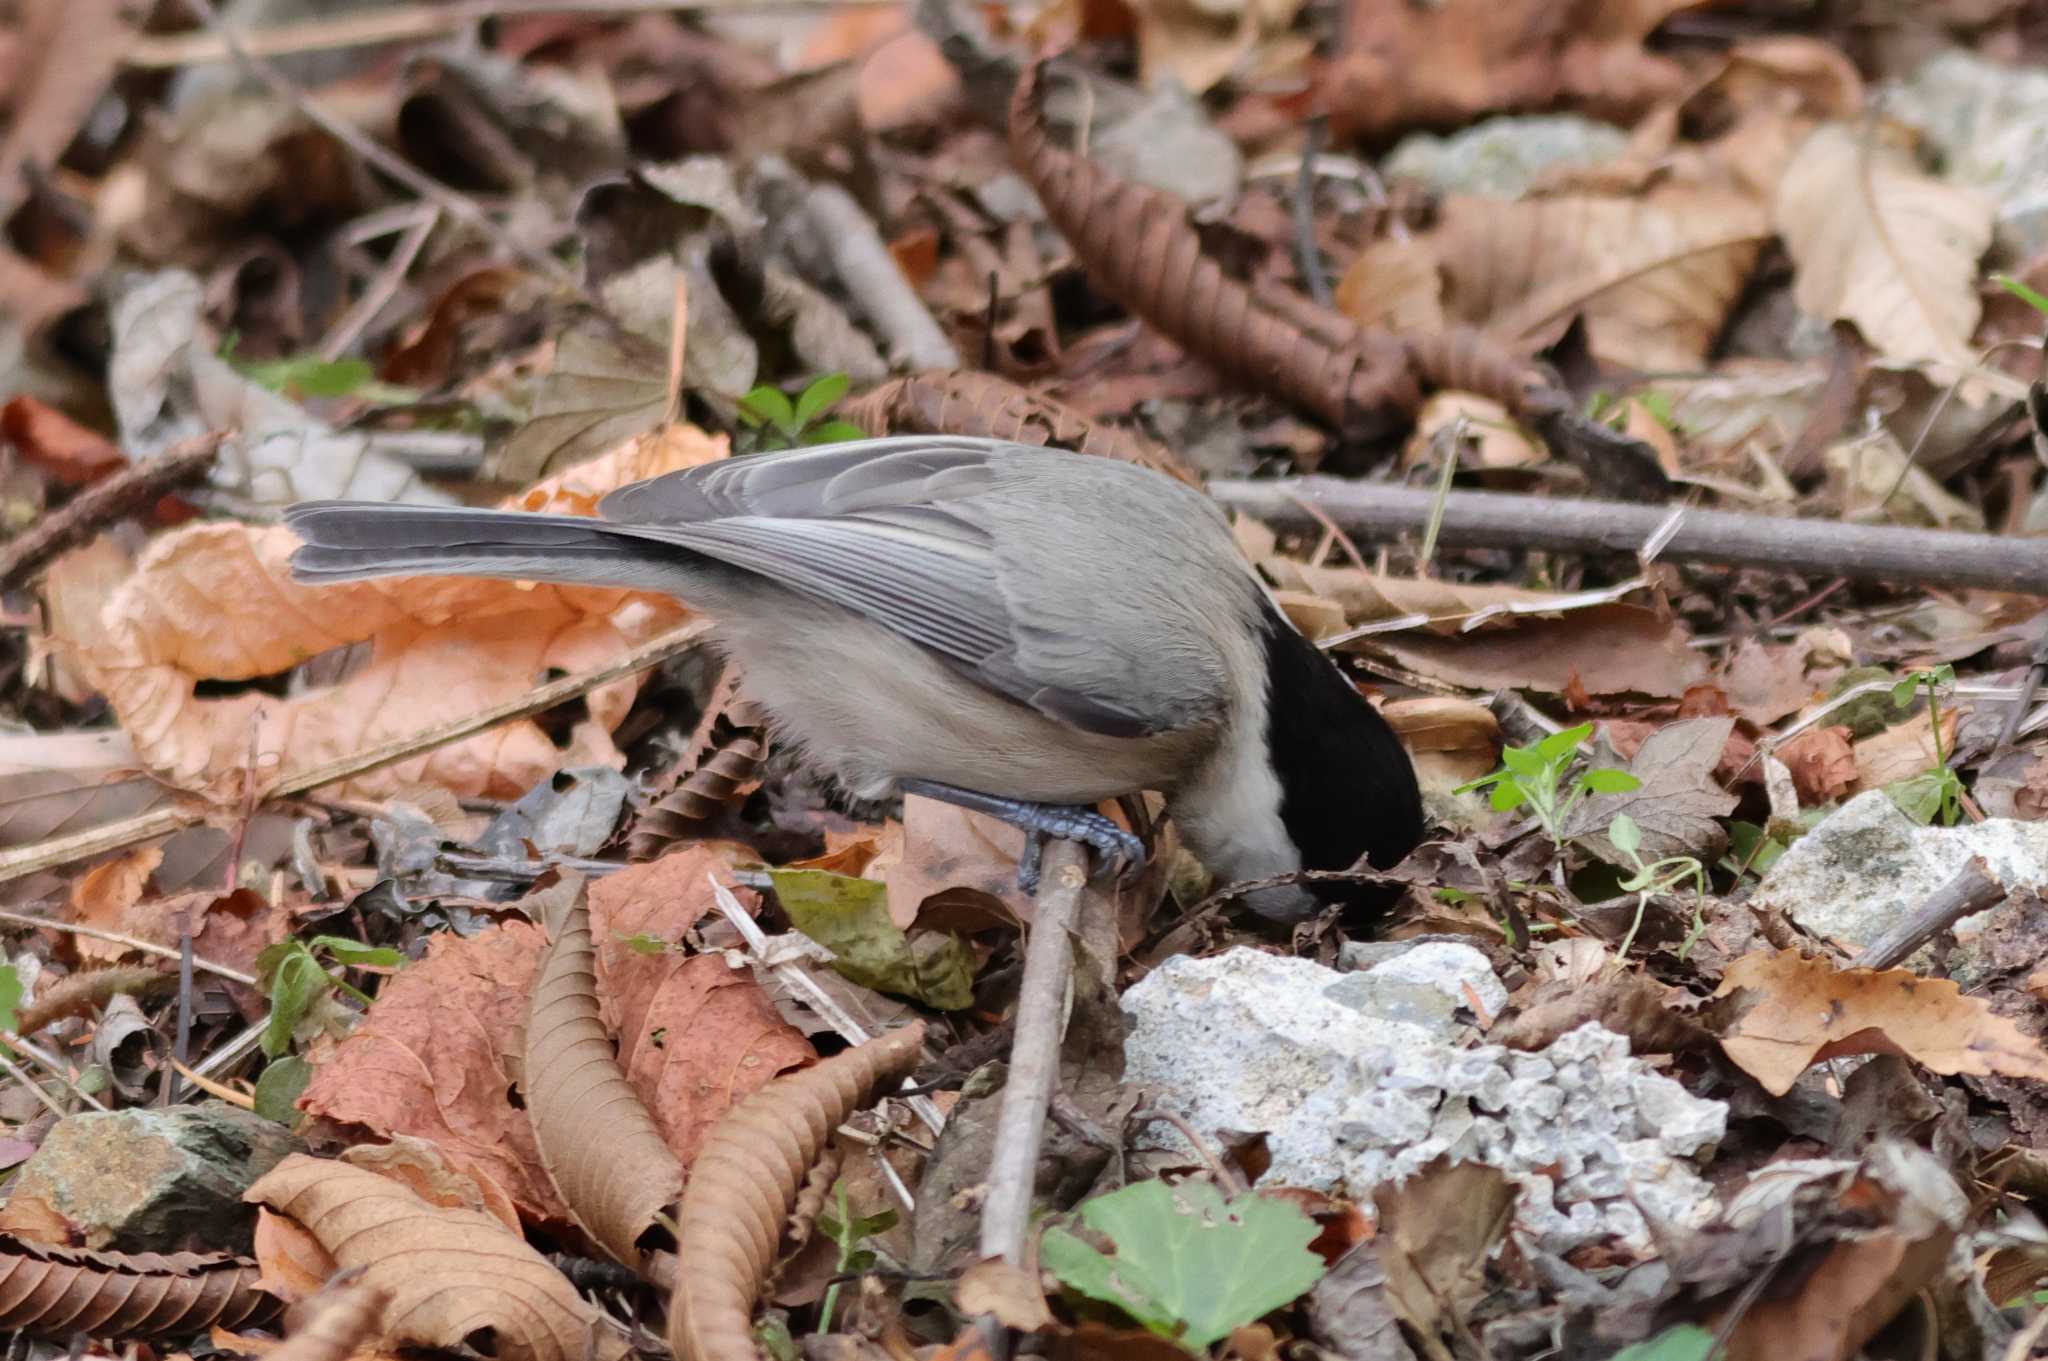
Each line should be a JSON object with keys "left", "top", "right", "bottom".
{"left": 844, "top": 370, "right": 1196, "bottom": 485}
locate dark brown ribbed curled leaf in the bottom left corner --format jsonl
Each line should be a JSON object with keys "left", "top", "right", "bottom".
{"left": 0, "top": 1234, "right": 279, "bottom": 1338}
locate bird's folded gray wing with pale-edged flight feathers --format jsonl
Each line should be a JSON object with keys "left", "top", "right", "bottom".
{"left": 598, "top": 436, "right": 1159, "bottom": 737}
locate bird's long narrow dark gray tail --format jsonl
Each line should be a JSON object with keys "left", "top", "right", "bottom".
{"left": 285, "top": 501, "right": 694, "bottom": 591}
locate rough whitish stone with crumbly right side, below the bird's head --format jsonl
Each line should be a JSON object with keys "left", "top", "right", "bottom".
{"left": 1124, "top": 950, "right": 1726, "bottom": 1253}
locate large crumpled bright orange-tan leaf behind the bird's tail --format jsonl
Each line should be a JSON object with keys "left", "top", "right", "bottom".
{"left": 59, "top": 426, "right": 725, "bottom": 800}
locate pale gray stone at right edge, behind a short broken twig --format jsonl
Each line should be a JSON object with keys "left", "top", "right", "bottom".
{"left": 1755, "top": 790, "right": 2048, "bottom": 950}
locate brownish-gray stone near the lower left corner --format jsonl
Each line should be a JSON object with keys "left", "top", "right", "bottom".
{"left": 0, "top": 1101, "right": 295, "bottom": 1253}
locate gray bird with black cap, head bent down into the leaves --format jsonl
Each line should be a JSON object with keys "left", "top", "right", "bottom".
{"left": 285, "top": 436, "right": 1423, "bottom": 921}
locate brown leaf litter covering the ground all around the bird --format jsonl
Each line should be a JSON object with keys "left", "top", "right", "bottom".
{"left": 0, "top": 0, "right": 2048, "bottom": 1361}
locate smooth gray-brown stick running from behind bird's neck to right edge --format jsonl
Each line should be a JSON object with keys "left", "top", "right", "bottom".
{"left": 1208, "top": 477, "right": 2048, "bottom": 596}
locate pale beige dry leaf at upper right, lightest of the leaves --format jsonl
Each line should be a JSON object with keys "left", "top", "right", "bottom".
{"left": 1774, "top": 123, "right": 1997, "bottom": 382}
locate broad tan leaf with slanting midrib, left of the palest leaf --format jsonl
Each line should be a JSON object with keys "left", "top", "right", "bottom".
{"left": 1427, "top": 188, "right": 1772, "bottom": 368}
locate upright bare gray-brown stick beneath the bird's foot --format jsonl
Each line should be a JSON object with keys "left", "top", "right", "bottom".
{"left": 981, "top": 841, "right": 1087, "bottom": 1265}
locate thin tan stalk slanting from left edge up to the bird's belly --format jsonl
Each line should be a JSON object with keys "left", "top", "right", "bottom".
{"left": 0, "top": 620, "right": 711, "bottom": 888}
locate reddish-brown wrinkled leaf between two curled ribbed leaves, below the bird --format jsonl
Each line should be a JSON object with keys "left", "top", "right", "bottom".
{"left": 590, "top": 845, "right": 815, "bottom": 1167}
